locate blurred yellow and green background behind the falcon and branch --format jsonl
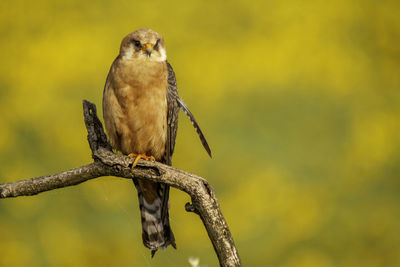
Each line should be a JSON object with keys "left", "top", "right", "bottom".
{"left": 0, "top": 0, "right": 400, "bottom": 267}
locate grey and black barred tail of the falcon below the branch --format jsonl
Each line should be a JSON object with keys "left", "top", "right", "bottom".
{"left": 133, "top": 179, "right": 176, "bottom": 257}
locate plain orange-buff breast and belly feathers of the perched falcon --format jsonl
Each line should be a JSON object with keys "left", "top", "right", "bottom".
{"left": 115, "top": 62, "right": 168, "bottom": 160}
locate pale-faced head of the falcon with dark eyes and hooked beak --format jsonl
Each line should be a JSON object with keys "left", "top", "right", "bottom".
{"left": 120, "top": 29, "right": 167, "bottom": 62}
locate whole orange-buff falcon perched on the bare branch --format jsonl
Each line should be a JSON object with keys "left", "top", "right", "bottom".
{"left": 103, "top": 29, "right": 211, "bottom": 257}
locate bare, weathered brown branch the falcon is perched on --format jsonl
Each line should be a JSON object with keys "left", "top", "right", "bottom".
{"left": 0, "top": 100, "right": 241, "bottom": 266}
